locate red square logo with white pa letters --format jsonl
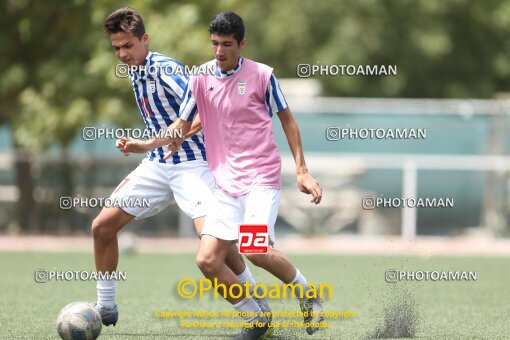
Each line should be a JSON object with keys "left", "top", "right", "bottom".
{"left": 238, "top": 224, "right": 269, "bottom": 254}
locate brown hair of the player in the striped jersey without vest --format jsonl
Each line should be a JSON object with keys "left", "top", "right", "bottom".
{"left": 103, "top": 7, "right": 145, "bottom": 39}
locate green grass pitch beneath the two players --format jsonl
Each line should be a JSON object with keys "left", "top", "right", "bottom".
{"left": 0, "top": 253, "right": 510, "bottom": 339}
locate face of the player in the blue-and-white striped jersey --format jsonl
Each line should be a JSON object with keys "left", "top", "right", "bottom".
{"left": 110, "top": 32, "right": 149, "bottom": 65}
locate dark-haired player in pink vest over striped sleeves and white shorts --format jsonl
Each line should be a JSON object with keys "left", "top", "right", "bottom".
{"left": 156, "top": 12, "right": 323, "bottom": 339}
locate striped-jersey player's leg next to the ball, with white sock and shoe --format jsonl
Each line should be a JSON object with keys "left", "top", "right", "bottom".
{"left": 92, "top": 208, "right": 135, "bottom": 326}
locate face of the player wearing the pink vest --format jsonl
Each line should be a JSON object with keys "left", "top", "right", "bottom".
{"left": 211, "top": 33, "right": 246, "bottom": 71}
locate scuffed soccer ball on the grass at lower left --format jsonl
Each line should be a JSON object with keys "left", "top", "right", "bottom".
{"left": 57, "top": 301, "right": 103, "bottom": 340}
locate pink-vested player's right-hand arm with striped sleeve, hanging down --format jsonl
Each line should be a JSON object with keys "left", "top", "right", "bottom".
{"left": 266, "top": 75, "right": 322, "bottom": 204}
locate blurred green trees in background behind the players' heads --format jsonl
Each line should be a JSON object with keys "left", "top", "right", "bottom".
{"left": 0, "top": 0, "right": 510, "bottom": 229}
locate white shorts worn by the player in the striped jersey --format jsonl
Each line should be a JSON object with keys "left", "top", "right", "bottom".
{"left": 110, "top": 159, "right": 215, "bottom": 220}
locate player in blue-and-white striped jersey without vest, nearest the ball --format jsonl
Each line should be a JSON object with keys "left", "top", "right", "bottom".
{"left": 92, "top": 8, "right": 269, "bottom": 326}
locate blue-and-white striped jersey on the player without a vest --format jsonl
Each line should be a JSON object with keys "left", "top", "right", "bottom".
{"left": 129, "top": 52, "right": 206, "bottom": 164}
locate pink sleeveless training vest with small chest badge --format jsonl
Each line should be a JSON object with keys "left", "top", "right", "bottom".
{"left": 189, "top": 59, "right": 281, "bottom": 196}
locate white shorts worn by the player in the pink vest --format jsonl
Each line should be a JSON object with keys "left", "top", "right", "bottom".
{"left": 202, "top": 187, "right": 281, "bottom": 245}
